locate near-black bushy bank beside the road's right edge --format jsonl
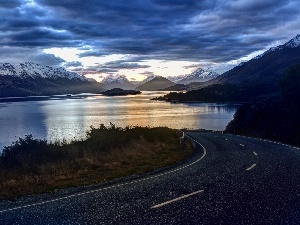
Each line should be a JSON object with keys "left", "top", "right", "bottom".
{"left": 225, "top": 65, "right": 300, "bottom": 146}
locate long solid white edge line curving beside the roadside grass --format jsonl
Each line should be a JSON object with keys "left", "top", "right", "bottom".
{"left": 0, "top": 131, "right": 206, "bottom": 213}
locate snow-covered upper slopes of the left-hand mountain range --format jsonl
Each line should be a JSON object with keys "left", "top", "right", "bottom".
{"left": 0, "top": 62, "right": 88, "bottom": 81}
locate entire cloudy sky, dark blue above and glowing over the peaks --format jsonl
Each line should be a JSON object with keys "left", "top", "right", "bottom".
{"left": 0, "top": 0, "right": 300, "bottom": 80}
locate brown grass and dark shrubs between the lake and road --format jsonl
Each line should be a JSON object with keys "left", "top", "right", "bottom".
{"left": 0, "top": 124, "right": 194, "bottom": 199}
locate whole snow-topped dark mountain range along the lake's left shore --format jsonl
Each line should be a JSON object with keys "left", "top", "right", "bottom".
{"left": 0, "top": 62, "right": 104, "bottom": 97}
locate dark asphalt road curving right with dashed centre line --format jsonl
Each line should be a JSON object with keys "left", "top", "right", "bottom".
{"left": 0, "top": 132, "right": 300, "bottom": 225}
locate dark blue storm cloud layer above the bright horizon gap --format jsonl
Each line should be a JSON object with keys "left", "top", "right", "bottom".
{"left": 0, "top": 0, "right": 300, "bottom": 65}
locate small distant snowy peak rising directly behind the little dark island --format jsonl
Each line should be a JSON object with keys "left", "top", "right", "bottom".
{"left": 100, "top": 75, "right": 135, "bottom": 90}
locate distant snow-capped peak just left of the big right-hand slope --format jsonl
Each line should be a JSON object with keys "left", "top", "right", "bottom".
{"left": 176, "top": 68, "right": 219, "bottom": 84}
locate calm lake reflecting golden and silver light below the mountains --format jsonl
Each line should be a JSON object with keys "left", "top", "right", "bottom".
{"left": 0, "top": 92, "right": 238, "bottom": 151}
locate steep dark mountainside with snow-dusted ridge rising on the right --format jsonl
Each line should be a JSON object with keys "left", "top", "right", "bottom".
{"left": 206, "top": 35, "right": 300, "bottom": 87}
